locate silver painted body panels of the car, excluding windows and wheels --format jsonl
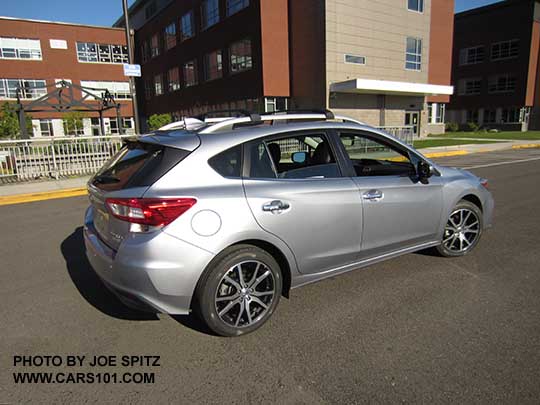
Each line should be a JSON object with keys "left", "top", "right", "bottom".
{"left": 85, "top": 121, "right": 493, "bottom": 314}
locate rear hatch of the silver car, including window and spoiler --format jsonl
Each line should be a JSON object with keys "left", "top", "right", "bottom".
{"left": 88, "top": 131, "right": 200, "bottom": 250}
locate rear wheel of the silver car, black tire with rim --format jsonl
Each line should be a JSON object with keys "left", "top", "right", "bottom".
{"left": 194, "top": 245, "right": 283, "bottom": 336}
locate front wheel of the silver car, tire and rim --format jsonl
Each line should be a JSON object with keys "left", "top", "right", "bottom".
{"left": 436, "top": 200, "right": 484, "bottom": 257}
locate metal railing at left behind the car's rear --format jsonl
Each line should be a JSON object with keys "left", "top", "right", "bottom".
{"left": 0, "top": 135, "right": 132, "bottom": 183}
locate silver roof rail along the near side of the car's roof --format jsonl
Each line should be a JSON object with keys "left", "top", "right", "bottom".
{"left": 196, "top": 113, "right": 366, "bottom": 134}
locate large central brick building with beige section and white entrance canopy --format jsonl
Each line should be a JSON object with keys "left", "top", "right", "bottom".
{"left": 115, "top": 0, "right": 454, "bottom": 135}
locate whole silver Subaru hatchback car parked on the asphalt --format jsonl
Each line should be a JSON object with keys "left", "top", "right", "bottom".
{"left": 84, "top": 111, "right": 493, "bottom": 336}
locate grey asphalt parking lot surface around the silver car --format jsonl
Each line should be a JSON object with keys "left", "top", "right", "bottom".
{"left": 0, "top": 150, "right": 540, "bottom": 404}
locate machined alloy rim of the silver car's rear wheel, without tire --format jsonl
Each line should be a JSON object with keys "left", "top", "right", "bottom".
{"left": 215, "top": 260, "right": 276, "bottom": 328}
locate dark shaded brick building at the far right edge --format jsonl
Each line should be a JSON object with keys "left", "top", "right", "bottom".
{"left": 447, "top": 0, "right": 540, "bottom": 131}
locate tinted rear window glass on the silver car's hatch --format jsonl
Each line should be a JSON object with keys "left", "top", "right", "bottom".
{"left": 92, "top": 142, "right": 189, "bottom": 191}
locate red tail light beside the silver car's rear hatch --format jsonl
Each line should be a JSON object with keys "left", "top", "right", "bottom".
{"left": 106, "top": 198, "right": 197, "bottom": 226}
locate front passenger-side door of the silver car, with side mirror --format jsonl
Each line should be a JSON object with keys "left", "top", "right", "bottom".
{"left": 339, "top": 131, "right": 442, "bottom": 258}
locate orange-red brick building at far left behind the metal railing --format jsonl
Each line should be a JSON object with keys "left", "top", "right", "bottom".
{"left": 0, "top": 17, "right": 134, "bottom": 137}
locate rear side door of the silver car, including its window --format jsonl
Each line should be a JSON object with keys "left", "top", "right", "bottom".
{"left": 244, "top": 132, "right": 362, "bottom": 273}
